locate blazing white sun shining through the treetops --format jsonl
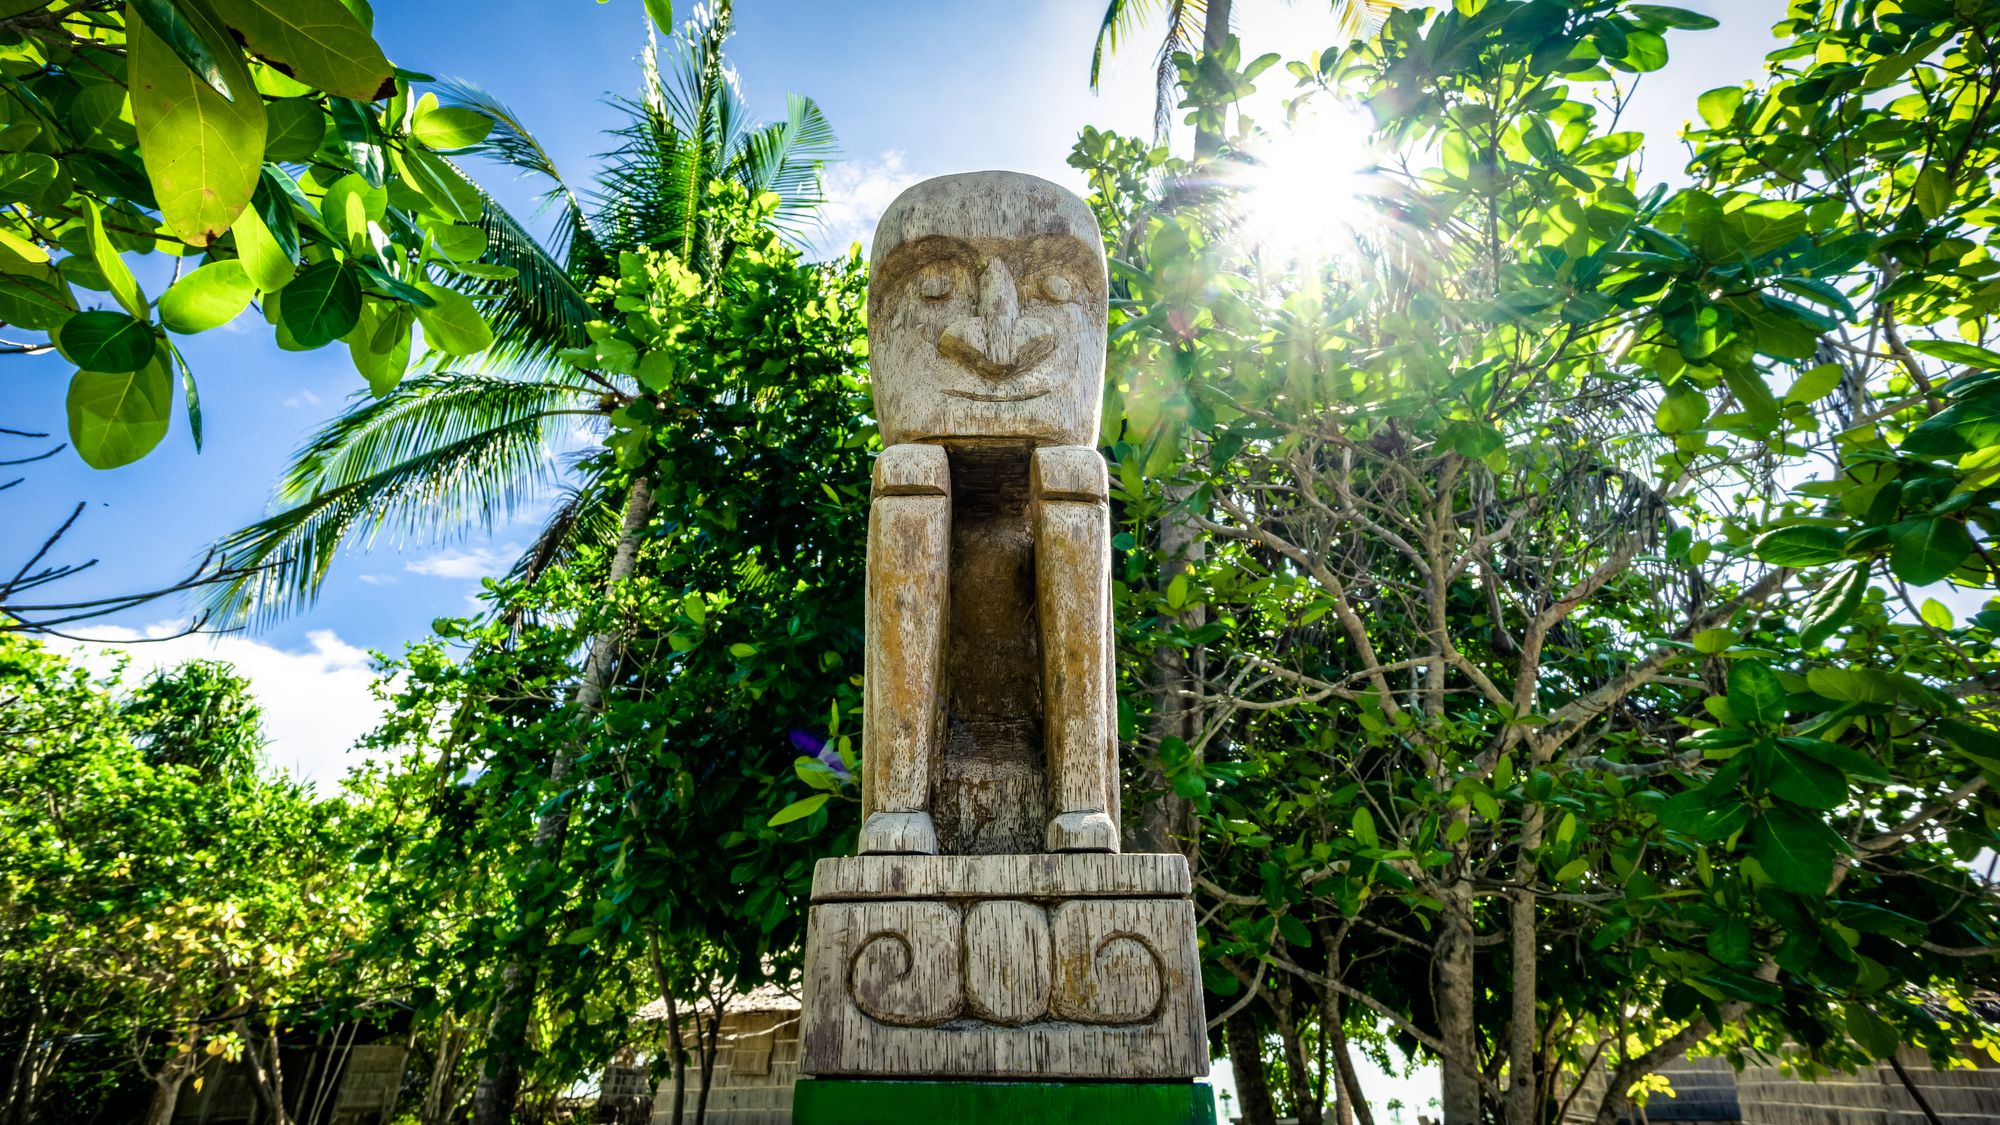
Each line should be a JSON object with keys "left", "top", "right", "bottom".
{"left": 1232, "top": 102, "right": 1382, "bottom": 260}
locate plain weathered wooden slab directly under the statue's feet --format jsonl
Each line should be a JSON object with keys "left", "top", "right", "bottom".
{"left": 812, "top": 853, "right": 1192, "bottom": 903}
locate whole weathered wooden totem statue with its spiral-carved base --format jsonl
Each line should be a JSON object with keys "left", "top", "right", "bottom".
{"left": 800, "top": 172, "right": 1208, "bottom": 1096}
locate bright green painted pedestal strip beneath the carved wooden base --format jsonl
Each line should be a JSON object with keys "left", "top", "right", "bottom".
{"left": 792, "top": 1079, "right": 1216, "bottom": 1125}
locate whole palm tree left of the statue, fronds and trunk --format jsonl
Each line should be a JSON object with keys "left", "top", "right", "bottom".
{"left": 212, "top": 0, "right": 834, "bottom": 1125}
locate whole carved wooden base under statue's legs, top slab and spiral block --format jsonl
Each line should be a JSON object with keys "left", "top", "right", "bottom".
{"left": 800, "top": 855, "right": 1208, "bottom": 1079}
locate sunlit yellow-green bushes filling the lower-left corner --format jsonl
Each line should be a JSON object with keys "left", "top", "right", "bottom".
{"left": 0, "top": 637, "right": 378, "bottom": 1121}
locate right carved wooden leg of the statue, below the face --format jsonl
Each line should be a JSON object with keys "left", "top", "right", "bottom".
{"left": 1028, "top": 446, "right": 1118, "bottom": 851}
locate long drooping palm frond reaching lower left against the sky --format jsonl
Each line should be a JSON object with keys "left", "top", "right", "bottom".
{"left": 208, "top": 372, "right": 586, "bottom": 621}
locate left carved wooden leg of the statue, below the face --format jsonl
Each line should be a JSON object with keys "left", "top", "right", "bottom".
{"left": 860, "top": 444, "right": 952, "bottom": 855}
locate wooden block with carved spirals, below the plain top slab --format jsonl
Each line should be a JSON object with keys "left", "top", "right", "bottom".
{"left": 800, "top": 899, "right": 1208, "bottom": 1079}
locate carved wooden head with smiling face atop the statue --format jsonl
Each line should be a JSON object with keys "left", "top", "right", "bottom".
{"left": 868, "top": 172, "right": 1106, "bottom": 444}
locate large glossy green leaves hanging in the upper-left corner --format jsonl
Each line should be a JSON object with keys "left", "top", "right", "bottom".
{"left": 0, "top": 0, "right": 508, "bottom": 468}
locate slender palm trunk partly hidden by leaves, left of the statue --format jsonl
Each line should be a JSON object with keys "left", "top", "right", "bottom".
{"left": 472, "top": 478, "right": 654, "bottom": 1125}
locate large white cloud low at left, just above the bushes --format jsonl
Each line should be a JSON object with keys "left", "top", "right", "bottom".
{"left": 50, "top": 625, "right": 382, "bottom": 791}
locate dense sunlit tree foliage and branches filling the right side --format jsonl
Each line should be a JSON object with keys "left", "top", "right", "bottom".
{"left": 1072, "top": 0, "right": 2000, "bottom": 1123}
